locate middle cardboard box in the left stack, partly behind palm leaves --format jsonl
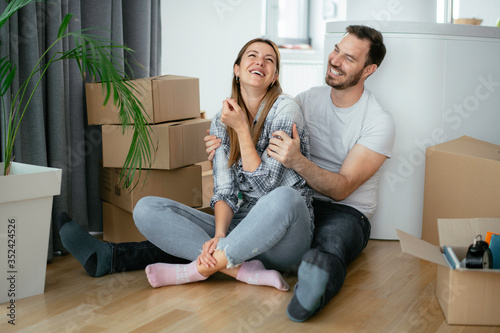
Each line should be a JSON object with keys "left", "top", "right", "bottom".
{"left": 102, "top": 118, "right": 211, "bottom": 170}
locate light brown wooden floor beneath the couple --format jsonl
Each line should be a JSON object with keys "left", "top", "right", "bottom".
{"left": 0, "top": 240, "right": 500, "bottom": 333}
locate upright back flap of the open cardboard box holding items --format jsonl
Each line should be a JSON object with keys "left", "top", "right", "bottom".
{"left": 437, "top": 218, "right": 500, "bottom": 247}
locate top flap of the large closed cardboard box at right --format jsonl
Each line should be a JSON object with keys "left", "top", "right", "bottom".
{"left": 427, "top": 135, "right": 500, "bottom": 162}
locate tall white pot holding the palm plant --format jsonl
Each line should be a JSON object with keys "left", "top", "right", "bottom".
{"left": 0, "top": 163, "right": 62, "bottom": 303}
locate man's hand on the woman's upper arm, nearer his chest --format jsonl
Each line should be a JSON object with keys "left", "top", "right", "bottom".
{"left": 267, "top": 124, "right": 304, "bottom": 169}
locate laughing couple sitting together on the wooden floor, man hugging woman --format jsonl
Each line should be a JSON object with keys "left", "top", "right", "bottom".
{"left": 58, "top": 26, "right": 394, "bottom": 321}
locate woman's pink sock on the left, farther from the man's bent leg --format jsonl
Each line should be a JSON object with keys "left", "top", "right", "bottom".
{"left": 146, "top": 261, "right": 207, "bottom": 288}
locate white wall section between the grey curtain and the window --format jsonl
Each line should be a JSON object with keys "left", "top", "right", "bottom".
{"left": 161, "top": 0, "right": 262, "bottom": 118}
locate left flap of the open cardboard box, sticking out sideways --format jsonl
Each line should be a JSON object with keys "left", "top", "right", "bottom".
{"left": 396, "top": 229, "right": 450, "bottom": 268}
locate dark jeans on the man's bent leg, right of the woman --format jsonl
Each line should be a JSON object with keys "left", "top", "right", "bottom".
{"left": 308, "top": 200, "right": 371, "bottom": 309}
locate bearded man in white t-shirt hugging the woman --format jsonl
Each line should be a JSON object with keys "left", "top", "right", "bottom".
{"left": 205, "top": 26, "right": 395, "bottom": 321}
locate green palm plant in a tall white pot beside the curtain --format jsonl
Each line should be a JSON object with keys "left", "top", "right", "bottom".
{"left": 0, "top": 0, "right": 153, "bottom": 303}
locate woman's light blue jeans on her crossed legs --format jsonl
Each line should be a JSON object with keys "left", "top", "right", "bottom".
{"left": 134, "top": 187, "right": 313, "bottom": 271}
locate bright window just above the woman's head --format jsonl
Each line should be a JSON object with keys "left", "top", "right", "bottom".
{"left": 265, "top": 0, "right": 310, "bottom": 46}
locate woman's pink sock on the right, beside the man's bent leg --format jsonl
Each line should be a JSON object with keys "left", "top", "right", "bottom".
{"left": 236, "top": 260, "right": 288, "bottom": 291}
